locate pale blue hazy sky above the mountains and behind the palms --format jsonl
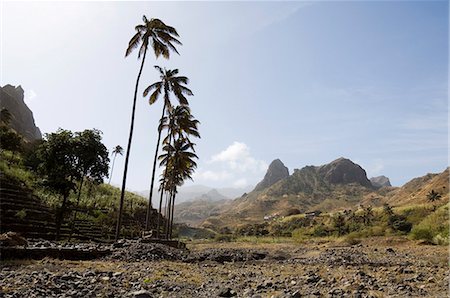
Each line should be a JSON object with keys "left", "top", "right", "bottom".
{"left": 0, "top": 1, "right": 449, "bottom": 191}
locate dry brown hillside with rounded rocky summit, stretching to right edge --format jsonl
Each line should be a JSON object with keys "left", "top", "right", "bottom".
{"left": 201, "top": 158, "right": 449, "bottom": 228}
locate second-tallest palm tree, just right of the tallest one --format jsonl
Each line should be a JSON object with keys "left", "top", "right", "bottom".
{"left": 144, "top": 65, "right": 194, "bottom": 230}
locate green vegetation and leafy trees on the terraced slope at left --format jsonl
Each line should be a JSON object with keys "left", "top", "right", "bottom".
{"left": 0, "top": 127, "right": 147, "bottom": 238}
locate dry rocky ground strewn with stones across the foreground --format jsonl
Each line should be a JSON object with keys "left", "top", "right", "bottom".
{"left": 0, "top": 238, "right": 449, "bottom": 298}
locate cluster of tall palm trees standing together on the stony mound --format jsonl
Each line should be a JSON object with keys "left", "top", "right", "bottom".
{"left": 116, "top": 16, "right": 200, "bottom": 240}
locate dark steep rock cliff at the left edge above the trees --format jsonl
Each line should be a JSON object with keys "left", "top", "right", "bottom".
{"left": 0, "top": 85, "right": 42, "bottom": 141}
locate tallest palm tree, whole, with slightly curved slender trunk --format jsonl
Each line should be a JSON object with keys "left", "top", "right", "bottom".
{"left": 115, "top": 15, "right": 181, "bottom": 241}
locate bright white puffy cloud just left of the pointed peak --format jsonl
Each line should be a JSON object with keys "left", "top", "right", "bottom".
{"left": 210, "top": 142, "right": 268, "bottom": 173}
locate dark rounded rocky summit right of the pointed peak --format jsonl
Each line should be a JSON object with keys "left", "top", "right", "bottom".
{"left": 318, "top": 157, "right": 372, "bottom": 187}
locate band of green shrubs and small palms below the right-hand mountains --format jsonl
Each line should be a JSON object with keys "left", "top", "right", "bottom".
{"left": 217, "top": 203, "right": 449, "bottom": 244}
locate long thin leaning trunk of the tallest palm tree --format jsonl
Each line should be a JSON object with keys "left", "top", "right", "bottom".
{"left": 115, "top": 49, "right": 147, "bottom": 241}
